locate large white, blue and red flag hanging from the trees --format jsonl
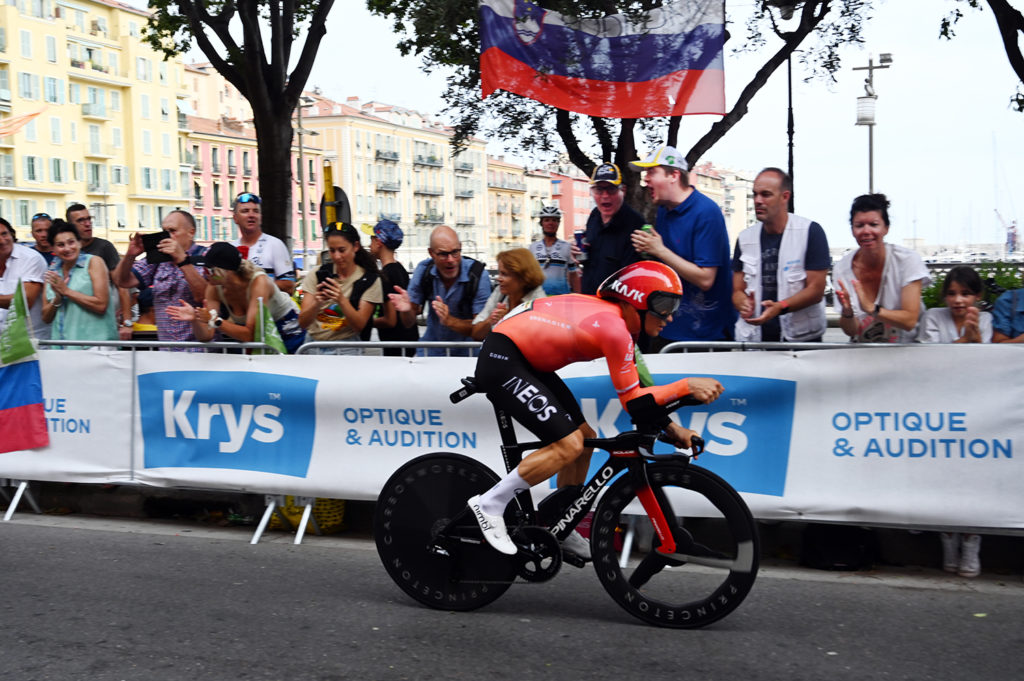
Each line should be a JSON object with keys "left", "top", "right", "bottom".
{"left": 480, "top": 0, "right": 725, "bottom": 118}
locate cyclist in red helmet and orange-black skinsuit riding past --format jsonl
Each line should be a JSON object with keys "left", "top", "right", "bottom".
{"left": 468, "top": 260, "right": 722, "bottom": 558}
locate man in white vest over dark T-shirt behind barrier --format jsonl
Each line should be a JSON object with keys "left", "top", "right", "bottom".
{"left": 732, "top": 168, "right": 831, "bottom": 342}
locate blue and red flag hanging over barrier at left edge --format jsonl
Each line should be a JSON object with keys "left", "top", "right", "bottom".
{"left": 0, "top": 359, "right": 50, "bottom": 453}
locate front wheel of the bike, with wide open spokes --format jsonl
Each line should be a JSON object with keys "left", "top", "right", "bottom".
{"left": 591, "top": 462, "right": 760, "bottom": 629}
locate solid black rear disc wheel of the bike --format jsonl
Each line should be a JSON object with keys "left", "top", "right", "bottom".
{"left": 374, "top": 453, "right": 518, "bottom": 610}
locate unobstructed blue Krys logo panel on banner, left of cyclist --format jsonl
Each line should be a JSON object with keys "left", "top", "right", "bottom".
{"left": 138, "top": 372, "right": 317, "bottom": 477}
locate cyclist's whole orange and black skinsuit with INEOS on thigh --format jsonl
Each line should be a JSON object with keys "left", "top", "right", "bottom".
{"left": 476, "top": 294, "right": 689, "bottom": 441}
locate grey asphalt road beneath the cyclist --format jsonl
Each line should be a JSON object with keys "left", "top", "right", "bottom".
{"left": 0, "top": 515, "right": 1024, "bottom": 681}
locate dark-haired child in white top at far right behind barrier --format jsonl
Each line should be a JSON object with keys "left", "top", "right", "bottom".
{"left": 919, "top": 265, "right": 992, "bottom": 577}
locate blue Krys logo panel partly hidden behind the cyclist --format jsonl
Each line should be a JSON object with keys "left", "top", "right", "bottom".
{"left": 565, "top": 374, "right": 797, "bottom": 497}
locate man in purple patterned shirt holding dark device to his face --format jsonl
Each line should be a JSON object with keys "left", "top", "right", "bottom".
{"left": 113, "top": 210, "right": 207, "bottom": 351}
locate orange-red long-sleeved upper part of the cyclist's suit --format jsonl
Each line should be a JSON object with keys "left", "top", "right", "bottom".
{"left": 494, "top": 294, "right": 690, "bottom": 406}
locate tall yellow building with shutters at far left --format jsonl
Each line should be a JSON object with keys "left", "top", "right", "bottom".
{"left": 0, "top": 0, "right": 190, "bottom": 251}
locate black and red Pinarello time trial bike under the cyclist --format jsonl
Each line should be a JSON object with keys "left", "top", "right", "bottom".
{"left": 374, "top": 378, "right": 759, "bottom": 629}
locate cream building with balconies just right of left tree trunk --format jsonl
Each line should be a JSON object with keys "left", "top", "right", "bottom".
{"left": 302, "top": 93, "right": 492, "bottom": 266}
